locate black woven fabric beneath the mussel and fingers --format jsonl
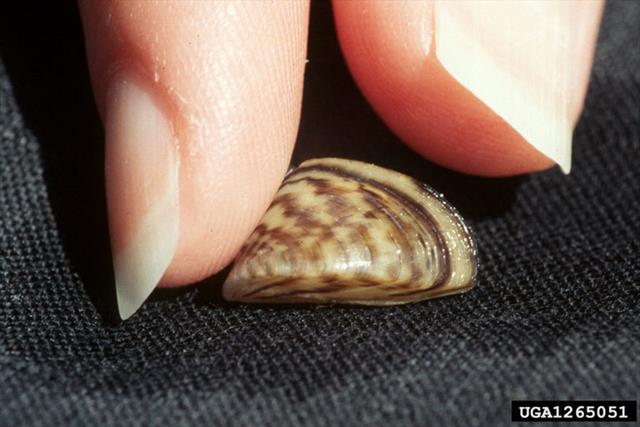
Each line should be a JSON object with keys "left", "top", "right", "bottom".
{"left": 0, "top": 1, "right": 640, "bottom": 427}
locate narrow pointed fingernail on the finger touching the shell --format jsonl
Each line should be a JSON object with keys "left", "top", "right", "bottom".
{"left": 105, "top": 73, "right": 179, "bottom": 320}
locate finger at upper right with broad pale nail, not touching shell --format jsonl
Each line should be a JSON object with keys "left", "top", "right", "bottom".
{"left": 334, "top": 0, "right": 602, "bottom": 176}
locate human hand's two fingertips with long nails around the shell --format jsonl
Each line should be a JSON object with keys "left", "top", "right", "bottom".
{"left": 80, "top": 0, "right": 602, "bottom": 318}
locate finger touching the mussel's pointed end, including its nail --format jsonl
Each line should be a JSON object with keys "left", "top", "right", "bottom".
{"left": 80, "top": 0, "right": 308, "bottom": 318}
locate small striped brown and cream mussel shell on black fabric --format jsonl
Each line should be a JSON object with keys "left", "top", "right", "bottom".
{"left": 223, "top": 158, "right": 477, "bottom": 305}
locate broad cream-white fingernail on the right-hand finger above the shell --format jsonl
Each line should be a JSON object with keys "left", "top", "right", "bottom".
{"left": 434, "top": 0, "right": 575, "bottom": 173}
